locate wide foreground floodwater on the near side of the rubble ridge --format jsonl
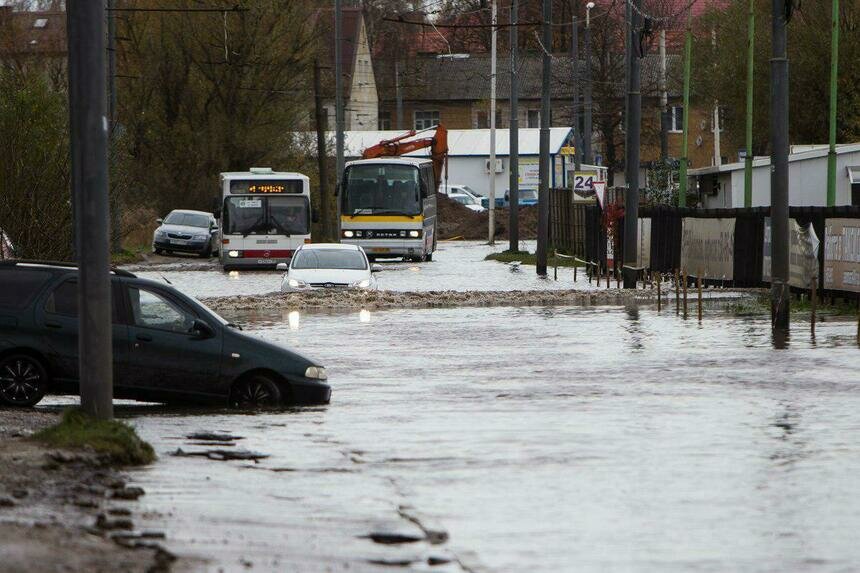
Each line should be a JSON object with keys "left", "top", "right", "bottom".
{"left": 107, "top": 308, "right": 860, "bottom": 573}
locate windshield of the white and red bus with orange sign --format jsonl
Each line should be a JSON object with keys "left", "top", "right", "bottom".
{"left": 223, "top": 195, "right": 310, "bottom": 237}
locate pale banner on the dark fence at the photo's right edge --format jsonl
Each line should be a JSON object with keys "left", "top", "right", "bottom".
{"left": 824, "top": 219, "right": 860, "bottom": 292}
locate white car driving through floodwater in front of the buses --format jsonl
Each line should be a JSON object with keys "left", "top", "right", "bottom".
{"left": 278, "top": 243, "right": 381, "bottom": 292}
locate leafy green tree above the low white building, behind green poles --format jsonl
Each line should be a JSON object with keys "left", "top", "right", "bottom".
{"left": 692, "top": 0, "right": 860, "bottom": 155}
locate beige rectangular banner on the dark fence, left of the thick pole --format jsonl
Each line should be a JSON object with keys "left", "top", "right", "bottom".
{"left": 681, "top": 217, "right": 735, "bottom": 280}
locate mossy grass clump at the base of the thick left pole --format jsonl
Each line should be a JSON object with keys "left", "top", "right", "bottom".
{"left": 33, "top": 408, "right": 155, "bottom": 466}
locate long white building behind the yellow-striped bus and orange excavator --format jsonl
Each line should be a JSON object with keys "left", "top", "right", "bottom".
{"left": 326, "top": 127, "right": 606, "bottom": 197}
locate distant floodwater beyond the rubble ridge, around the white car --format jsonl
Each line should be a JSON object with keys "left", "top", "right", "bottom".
{"left": 134, "top": 241, "right": 597, "bottom": 298}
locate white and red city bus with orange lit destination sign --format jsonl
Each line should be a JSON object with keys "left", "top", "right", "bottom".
{"left": 220, "top": 167, "right": 311, "bottom": 270}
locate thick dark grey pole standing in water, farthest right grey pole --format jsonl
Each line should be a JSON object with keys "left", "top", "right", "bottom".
{"left": 770, "top": 0, "right": 791, "bottom": 332}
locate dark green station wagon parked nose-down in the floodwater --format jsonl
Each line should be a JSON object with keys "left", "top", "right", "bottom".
{"left": 0, "top": 261, "right": 331, "bottom": 408}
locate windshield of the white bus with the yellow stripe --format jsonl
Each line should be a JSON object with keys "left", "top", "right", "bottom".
{"left": 343, "top": 164, "right": 422, "bottom": 215}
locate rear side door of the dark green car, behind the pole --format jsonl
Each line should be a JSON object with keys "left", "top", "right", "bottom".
{"left": 36, "top": 277, "right": 128, "bottom": 391}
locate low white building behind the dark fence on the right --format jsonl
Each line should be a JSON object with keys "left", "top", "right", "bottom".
{"left": 689, "top": 144, "right": 860, "bottom": 209}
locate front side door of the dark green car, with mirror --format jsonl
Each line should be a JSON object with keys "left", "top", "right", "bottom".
{"left": 125, "top": 283, "right": 223, "bottom": 401}
